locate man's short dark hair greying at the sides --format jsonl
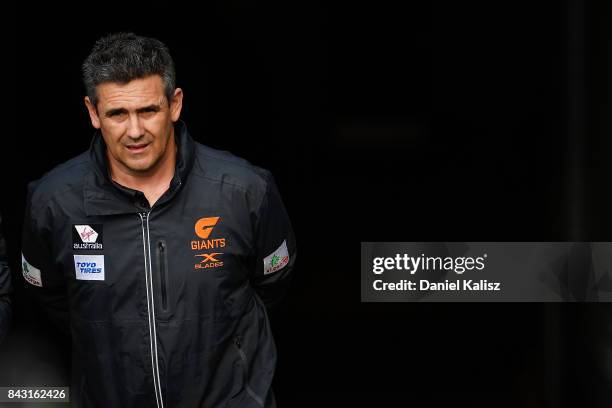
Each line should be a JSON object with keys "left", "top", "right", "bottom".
{"left": 82, "top": 33, "right": 176, "bottom": 107}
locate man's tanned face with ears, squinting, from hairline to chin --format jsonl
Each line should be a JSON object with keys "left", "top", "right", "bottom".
{"left": 85, "top": 75, "right": 183, "bottom": 175}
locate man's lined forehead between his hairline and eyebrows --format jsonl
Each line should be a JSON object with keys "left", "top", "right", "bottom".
{"left": 96, "top": 75, "right": 165, "bottom": 109}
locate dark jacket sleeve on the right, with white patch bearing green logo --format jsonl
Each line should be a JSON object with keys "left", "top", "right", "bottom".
{"left": 251, "top": 171, "right": 296, "bottom": 308}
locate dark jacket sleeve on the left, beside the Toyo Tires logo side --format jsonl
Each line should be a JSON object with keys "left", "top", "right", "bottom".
{"left": 21, "top": 186, "right": 70, "bottom": 335}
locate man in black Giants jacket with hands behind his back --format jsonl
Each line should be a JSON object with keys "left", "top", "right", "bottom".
{"left": 23, "top": 34, "right": 296, "bottom": 408}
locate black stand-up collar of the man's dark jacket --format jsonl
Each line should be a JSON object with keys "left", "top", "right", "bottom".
{"left": 83, "top": 120, "right": 195, "bottom": 216}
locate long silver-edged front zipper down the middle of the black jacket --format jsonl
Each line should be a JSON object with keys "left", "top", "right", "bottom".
{"left": 138, "top": 211, "right": 164, "bottom": 408}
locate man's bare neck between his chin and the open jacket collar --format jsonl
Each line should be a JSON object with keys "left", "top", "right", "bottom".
{"left": 107, "top": 132, "right": 176, "bottom": 206}
